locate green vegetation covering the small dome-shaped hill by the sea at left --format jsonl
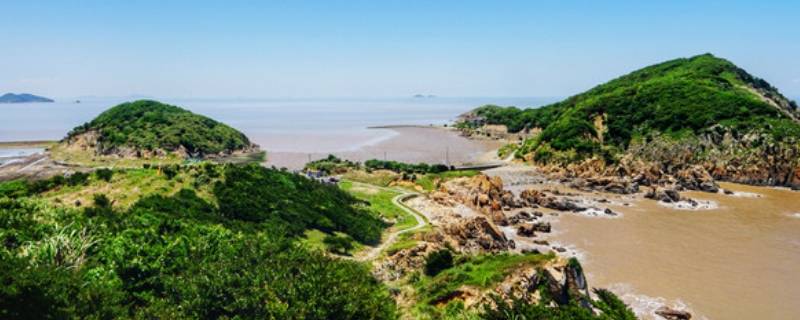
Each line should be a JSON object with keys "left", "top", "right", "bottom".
{"left": 67, "top": 100, "right": 250, "bottom": 156}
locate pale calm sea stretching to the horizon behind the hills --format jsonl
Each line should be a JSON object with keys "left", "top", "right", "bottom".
{"left": 0, "top": 97, "right": 559, "bottom": 153}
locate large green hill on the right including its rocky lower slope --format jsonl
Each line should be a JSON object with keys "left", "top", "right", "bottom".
{"left": 466, "top": 54, "right": 800, "bottom": 185}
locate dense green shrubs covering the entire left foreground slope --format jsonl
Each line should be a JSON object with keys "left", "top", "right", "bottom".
{"left": 0, "top": 165, "right": 396, "bottom": 319}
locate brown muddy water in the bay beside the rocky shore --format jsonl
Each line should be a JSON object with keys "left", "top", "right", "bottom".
{"left": 553, "top": 183, "right": 800, "bottom": 319}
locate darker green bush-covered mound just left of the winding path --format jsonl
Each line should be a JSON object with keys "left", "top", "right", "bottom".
{"left": 214, "top": 164, "right": 384, "bottom": 244}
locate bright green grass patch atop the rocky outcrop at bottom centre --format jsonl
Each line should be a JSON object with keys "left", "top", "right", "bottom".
{"left": 412, "top": 253, "right": 555, "bottom": 305}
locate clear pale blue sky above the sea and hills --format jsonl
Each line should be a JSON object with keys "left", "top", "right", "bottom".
{"left": 0, "top": 0, "right": 800, "bottom": 98}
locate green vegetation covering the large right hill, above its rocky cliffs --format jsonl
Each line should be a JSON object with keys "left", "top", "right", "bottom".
{"left": 468, "top": 54, "right": 800, "bottom": 162}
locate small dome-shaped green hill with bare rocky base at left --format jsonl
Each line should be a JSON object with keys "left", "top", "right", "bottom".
{"left": 58, "top": 100, "right": 258, "bottom": 158}
